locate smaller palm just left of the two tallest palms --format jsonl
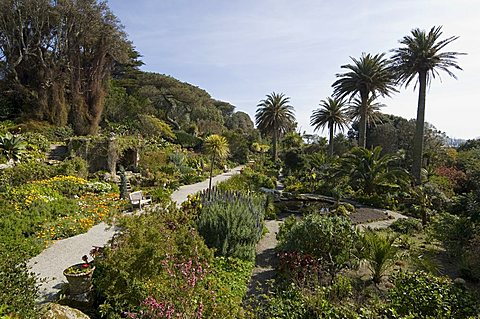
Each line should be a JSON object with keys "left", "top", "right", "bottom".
{"left": 310, "top": 97, "right": 348, "bottom": 156}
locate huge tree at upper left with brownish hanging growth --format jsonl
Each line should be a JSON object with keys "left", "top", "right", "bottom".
{"left": 0, "top": 0, "right": 130, "bottom": 134}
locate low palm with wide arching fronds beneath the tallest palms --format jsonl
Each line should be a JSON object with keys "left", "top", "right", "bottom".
{"left": 336, "top": 146, "right": 408, "bottom": 195}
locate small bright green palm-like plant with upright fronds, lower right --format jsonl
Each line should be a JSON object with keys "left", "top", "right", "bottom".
{"left": 362, "top": 229, "right": 399, "bottom": 284}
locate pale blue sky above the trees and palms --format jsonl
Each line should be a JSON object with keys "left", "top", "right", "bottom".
{"left": 109, "top": 0, "right": 480, "bottom": 138}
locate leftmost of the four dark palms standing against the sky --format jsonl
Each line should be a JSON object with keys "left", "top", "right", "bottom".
{"left": 255, "top": 92, "right": 295, "bottom": 161}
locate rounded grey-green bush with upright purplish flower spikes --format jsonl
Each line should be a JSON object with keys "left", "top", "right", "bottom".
{"left": 196, "top": 193, "right": 265, "bottom": 260}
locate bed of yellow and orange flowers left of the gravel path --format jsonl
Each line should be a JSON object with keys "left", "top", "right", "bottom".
{"left": 0, "top": 176, "right": 125, "bottom": 256}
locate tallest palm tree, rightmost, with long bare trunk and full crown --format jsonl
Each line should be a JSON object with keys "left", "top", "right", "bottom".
{"left": 392, "top": 26, "right": 464, "bottom": 184}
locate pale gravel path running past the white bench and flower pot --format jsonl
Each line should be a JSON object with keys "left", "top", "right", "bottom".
{"left": 28, "top": 166, "right": 243, "bottom": 302}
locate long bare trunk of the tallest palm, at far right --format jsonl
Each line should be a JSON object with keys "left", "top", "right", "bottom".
{"left": 412, "top": 71, "right": 427, "bottom": 185}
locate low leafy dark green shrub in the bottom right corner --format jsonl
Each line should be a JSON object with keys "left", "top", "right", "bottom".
{"left": 388, "top": 272, "right": 478, "bottom": 319}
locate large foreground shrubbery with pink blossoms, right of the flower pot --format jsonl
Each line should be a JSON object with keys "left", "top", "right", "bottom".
{"left": 94, "top": 205, "right": 244, "bottom": 318}
